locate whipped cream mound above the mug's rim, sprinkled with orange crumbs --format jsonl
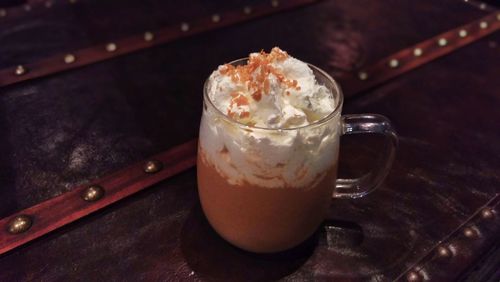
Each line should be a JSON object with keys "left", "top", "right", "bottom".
{"left": 208, "top": 47, "right": 335, "bottom": 128}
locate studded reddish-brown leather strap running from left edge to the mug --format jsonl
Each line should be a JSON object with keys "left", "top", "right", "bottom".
{"left": 0, "top": 140, "right": 197, "bottom": 254}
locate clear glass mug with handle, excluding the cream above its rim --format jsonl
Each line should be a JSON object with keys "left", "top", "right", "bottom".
{"left": 197, "top": 58, "right": 398, "bottom": 253}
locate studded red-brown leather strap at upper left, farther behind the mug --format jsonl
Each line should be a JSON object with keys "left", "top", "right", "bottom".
{"left": 0, "top": 0, "right": 317, "bottom": 87}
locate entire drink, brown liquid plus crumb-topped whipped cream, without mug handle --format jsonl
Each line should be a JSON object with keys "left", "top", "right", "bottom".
{"left": 198, "top": 48, "right": 340, "bottom": 252}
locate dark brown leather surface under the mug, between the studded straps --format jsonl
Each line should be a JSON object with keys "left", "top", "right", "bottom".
{"left": 0, "top": 0, "right": 500, "bottom": 281}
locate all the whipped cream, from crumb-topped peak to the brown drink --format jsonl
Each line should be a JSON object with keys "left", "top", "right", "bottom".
{"left": 200, "top": 47, "right": 340, "bottom": 188}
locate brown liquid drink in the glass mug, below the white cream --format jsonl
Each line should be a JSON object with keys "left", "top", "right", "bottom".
{"left": 198, "top": 149, "right": 337, "bottom": 253}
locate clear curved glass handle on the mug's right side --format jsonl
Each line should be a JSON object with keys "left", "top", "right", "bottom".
{"left": 332, "top": 114, "right": 398, "bottom": 199}
